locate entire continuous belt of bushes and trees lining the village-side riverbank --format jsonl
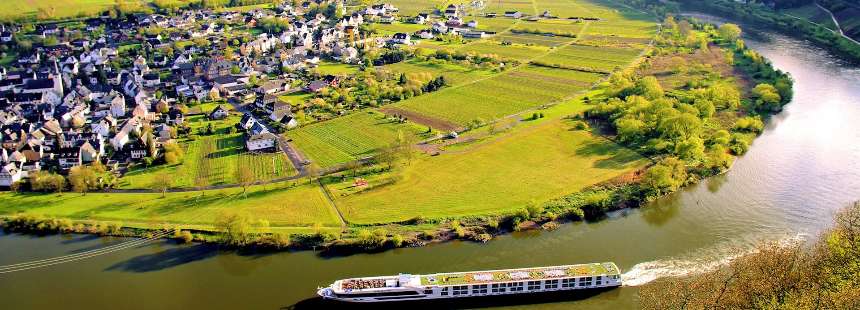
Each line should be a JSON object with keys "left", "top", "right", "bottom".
{"left": 2, "top": 17, "right": 792, "bottom": 255}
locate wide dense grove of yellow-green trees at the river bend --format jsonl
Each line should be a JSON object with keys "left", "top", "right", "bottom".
{"left": 582, "top": 16, "right": 793, "bottom": 203}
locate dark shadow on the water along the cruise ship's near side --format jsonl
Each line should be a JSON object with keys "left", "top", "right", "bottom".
{"left": 281, "top": 289, "right": 620, "bottom": 310}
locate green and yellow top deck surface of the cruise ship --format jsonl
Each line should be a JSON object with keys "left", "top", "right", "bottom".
{"left": 421, "top": 263, "right": 620, "bottom": 286}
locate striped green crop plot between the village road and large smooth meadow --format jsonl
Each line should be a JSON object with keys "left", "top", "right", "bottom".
{"left": 286, "top": 111, "right": 426, "bottom": 168}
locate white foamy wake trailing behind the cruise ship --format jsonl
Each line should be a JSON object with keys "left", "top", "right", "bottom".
{"left": 621, "top": 234, "right": 805, "bottom": 286}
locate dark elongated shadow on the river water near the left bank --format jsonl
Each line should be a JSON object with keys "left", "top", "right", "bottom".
{"left": 105, "top": 244, "right": 219, "bottom": 273}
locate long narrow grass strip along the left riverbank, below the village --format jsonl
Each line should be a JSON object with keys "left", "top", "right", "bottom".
{"left": 0, "top": 184, "right": 340, "bottom": 226}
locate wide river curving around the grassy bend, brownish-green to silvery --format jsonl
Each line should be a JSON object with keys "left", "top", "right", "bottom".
{"left": 0, "top": 18, "right": 860, "bottom": 309}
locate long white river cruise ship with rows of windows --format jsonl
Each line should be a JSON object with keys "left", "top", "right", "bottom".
{"left": 317, "top": 262, "right": 621, "bottom": 303}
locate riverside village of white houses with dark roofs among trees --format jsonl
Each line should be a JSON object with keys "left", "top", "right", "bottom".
{"left": 0, "top": 0, "right": 521, "bottom": 188}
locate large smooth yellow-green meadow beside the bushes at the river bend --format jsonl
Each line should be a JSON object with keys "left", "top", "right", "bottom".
{"left": 335, "top": 99, "right": 645, "bottom": 224}
